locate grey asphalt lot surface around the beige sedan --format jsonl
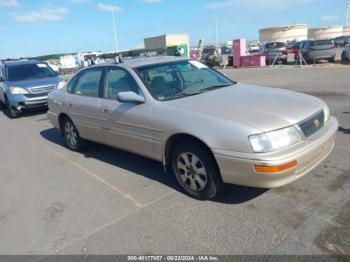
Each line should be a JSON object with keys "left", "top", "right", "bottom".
{"left": 0, "top": 67, "right": 350, "bottom": 255}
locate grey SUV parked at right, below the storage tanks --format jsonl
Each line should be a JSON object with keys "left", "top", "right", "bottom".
{"left": 301, "top": 40, "right": 336, "bottom": 64}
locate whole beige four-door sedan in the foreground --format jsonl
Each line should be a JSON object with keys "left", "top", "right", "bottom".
{"left": 47, "top": 57, "right": 338, "bottom": 199}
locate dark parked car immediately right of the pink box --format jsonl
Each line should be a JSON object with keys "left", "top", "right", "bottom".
{"left": 262, "top": 42, "right": 288, "bottom": 65}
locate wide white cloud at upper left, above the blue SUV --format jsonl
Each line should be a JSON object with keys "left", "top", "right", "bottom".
{"left": 12, "top": 6, "right": 69, "bottom": 23}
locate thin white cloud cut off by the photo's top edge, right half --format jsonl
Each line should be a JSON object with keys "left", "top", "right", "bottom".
{"left": 206, "top": 0, "right": 316, "bottom": 10}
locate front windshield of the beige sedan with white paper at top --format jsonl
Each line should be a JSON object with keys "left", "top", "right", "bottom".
{"left": 136, "top": 61, "right": 235, "bottom": 101}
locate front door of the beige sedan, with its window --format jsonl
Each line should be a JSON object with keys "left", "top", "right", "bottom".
{"left": 100, "top": 67, "right": 155, "bottom": 158}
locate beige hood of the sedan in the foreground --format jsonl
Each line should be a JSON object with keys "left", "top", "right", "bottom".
{"left": 166, "top": 84, "right": 324, "bottom": 132}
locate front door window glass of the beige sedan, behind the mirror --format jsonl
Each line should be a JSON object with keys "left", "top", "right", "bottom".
{"left": 103, "top": 68, "right": 141, "bottom": 99}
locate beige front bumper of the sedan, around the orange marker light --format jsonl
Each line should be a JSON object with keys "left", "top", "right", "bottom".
{"left": 214, "top": 117, "right": 338, "bottom": 188}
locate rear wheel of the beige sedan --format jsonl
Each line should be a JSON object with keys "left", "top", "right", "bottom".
{"left": 62, "top": 117, "right": 86, "bottom": 151}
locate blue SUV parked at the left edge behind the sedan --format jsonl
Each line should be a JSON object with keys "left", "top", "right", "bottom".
{"left": 0, "top": 60, "right": 64, "bottom": 118}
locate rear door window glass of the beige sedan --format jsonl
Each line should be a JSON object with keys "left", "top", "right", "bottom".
{"left": 72, "top": 68, "right": 103, "bottom": 97}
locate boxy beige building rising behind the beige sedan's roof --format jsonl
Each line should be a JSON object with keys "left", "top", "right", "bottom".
{"left": 144, "top": 34, "right": 190, "bottom": 57}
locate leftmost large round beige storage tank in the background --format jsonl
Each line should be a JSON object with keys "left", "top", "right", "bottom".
{"left": 259, "top": 24, "right": 308, "bottom": 43}
